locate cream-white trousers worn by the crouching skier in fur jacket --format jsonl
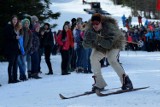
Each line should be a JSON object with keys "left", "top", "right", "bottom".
{"left": 90, "top": 49, "right": 125, "bottom": 88}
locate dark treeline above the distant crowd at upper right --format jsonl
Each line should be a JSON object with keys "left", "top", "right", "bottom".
{"left": 112, "top": 0, "right": 160, "bottom": 19}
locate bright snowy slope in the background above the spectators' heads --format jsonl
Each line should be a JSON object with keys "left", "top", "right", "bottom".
{"left": 50, "top": 0, "right": 140, "bottom": 31}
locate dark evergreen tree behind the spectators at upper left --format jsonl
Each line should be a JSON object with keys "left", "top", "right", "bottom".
{"left": 0, "top": 0, "right": 60, "bottom": 58}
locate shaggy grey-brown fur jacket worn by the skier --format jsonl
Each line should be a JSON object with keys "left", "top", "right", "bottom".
{"left": 83, "top": 16, "right": 125, "bottom": 53}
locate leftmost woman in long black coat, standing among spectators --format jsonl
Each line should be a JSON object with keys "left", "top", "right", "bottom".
{"left": 5, "top": 16, "right": 19, "bottom": 83}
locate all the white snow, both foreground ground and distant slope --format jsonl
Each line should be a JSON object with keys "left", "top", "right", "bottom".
{"left": 0, "top": 0, "right": 160, "bottom": 107}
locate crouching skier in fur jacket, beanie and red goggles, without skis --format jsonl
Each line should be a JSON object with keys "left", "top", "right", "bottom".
{"left": 83, "top": 13, "right": 133, "bottom": 92}
